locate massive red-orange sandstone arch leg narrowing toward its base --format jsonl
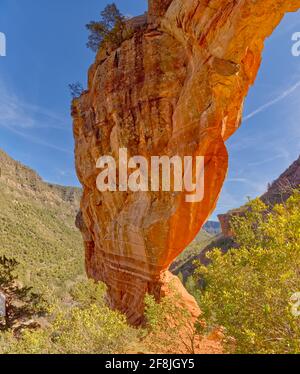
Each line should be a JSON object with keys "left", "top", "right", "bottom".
{"left": 72, "top": 0, "right": 300, "bottom": 324}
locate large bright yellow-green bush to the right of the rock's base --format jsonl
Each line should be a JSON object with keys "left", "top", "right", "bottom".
{"left": 196, "top": 191, "right": 300, "bottom": 353}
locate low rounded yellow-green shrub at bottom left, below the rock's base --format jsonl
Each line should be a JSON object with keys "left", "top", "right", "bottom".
{"left": 6, "top": 305, "right": 135, "bottom": 354}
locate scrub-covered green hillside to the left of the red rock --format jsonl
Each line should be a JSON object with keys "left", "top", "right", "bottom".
{"left": 0, "top": 150, "right": 84, "bottom": 295}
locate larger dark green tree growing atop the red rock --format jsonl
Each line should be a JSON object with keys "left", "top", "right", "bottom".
{"left": 86, "top": 3, "right": 132, "bottom": 52}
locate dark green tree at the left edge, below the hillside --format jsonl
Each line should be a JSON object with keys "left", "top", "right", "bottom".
{"left": 0, "top": 256, "right": 46, "bottom": 333}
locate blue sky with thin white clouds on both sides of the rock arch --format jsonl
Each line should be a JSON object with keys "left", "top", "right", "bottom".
{"left": 0, "top": 0, "right": 300, "bottom": 218}
